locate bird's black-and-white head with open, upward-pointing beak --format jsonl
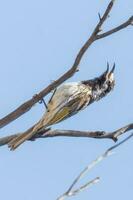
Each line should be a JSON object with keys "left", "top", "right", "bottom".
{"left": 82, "top": 63, "right": 115, "bottom": 100}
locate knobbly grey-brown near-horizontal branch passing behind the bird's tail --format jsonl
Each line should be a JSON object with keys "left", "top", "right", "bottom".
{"left": 0, "top": 123, "right": 133, "bottom": 146}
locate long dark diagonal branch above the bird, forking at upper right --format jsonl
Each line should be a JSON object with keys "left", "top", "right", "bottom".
{"left": 0, "top": 0, "right": 133, "bottom": 128}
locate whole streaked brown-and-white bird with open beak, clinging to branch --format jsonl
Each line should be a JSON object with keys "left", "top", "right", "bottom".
{"left": 8, "top": 63, "right": 115, "bottom": 150}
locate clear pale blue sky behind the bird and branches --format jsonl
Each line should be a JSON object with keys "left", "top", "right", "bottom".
{"left": 0, "top": 0, "right": 133, "bottom": 200}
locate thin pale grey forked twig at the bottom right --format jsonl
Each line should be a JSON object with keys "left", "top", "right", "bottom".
{"left": 57, "top": 133, "right": 133, "bottom": 200}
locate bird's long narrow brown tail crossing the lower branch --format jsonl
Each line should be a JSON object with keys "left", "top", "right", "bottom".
{"left": 8, "top": 121, "right": 45, "bottom": 150}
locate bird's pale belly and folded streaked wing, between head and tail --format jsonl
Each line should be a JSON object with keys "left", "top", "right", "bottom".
{"left": 42, "top": 83, "right": 90, "bottom": 126}
